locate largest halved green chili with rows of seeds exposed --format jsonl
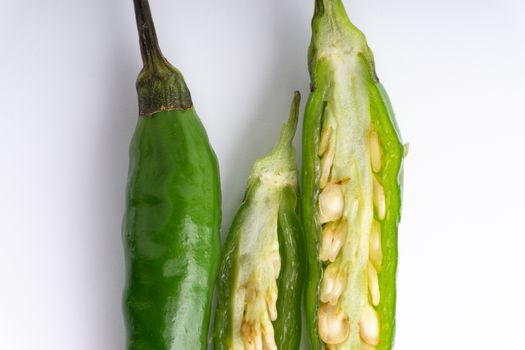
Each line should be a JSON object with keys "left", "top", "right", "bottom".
{"left": 302, "top": 0, "right": 403, "bottom": 350}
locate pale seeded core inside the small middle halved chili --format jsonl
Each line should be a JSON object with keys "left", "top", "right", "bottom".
{"left": 232, "top": 171, "right": 297, "bottom": 350}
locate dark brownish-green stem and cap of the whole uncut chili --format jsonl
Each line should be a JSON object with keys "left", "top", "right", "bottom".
{"left": 133, "top": 0, "right": 193, "bottom": 117}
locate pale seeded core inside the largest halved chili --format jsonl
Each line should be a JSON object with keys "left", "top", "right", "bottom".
{"left": 317, "top": 52, "right": 386, "bottom": 350}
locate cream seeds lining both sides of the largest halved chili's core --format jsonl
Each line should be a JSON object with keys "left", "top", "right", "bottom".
{"left": 318, "top": 127, "right": 386, "bottom": 350}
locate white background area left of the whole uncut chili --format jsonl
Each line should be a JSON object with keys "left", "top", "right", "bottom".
{"left": 0, "top": 0, "right": 135, "bottom": 350}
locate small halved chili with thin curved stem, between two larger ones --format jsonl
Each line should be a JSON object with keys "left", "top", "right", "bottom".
{"left": 214, "top": 92, "right": 304, "bottom": 350}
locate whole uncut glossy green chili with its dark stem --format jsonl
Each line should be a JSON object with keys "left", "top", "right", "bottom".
{"left": 123, "top": 0, "right": 221, "bottom": 350}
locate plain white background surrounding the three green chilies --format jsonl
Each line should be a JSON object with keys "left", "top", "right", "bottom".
{"left": 0, "top": 0, "right": 525, "bottom": 350}
